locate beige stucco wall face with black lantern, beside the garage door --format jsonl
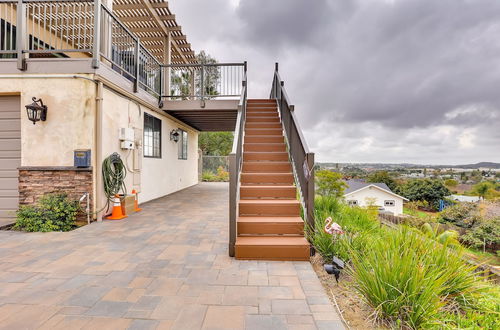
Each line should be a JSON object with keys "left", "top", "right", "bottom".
{"left": 0, "top": 78, "right": 95, "bottom": 166}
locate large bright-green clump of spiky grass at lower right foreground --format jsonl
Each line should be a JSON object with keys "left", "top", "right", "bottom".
{"left": 348, "top": 227, "right": 484, "bottom": 328}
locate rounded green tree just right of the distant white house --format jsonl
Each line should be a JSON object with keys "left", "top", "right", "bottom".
{"left": 397, "top": 179, "right": 451, "bottom": 209}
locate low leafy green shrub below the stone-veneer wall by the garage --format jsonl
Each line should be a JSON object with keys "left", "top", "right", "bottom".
{"left": 14, "top": 194, "right": 79, "bottom": 232}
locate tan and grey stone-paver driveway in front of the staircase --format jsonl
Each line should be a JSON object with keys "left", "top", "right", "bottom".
{"left": 0, "top": 183, "right": 343, "bottom": 330}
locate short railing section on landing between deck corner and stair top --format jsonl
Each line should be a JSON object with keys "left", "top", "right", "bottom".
{"left": 162, "top": 62, "right": 246, "bottom": 100}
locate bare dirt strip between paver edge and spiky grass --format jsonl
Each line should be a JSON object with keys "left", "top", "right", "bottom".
{"left": 311, "top": 254, "right": 388, "bottom": 330}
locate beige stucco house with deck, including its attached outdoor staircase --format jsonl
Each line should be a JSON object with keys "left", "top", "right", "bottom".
{"left": 0, "top": 0, "right": 314, "bottom": 260}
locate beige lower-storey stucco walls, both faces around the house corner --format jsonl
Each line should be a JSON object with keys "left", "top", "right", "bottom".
{"left": 0, "top": 75, "right": 198, "bottom": 214}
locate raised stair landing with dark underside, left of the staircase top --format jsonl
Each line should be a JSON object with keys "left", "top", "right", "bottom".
{"left": 163, "top": 100, "right": 239, "bottom": 132}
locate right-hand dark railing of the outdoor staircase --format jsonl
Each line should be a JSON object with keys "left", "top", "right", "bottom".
{"left": 270, "top": 63, "right": 315, "bottom": 227}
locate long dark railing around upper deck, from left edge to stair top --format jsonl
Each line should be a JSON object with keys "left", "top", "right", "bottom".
{"left": 0, "top": 0, "right": 246, "bottom": 100}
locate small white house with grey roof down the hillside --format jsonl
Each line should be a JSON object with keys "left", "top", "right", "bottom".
{"left": 344, "top": 180, "right": 408, "bottom": 215}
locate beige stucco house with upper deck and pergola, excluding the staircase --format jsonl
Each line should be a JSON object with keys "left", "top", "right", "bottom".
{"left": 0, "top": 0, "right": 243, "bottom": 221}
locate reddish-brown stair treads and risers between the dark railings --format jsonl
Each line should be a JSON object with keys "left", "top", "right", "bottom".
{"left": 235, "top": 99, "right": 310, "bottom": 260}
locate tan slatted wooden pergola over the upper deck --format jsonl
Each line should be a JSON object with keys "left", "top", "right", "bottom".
{"left": 112, "top": 0, "right": 197, "bottom": 64}
